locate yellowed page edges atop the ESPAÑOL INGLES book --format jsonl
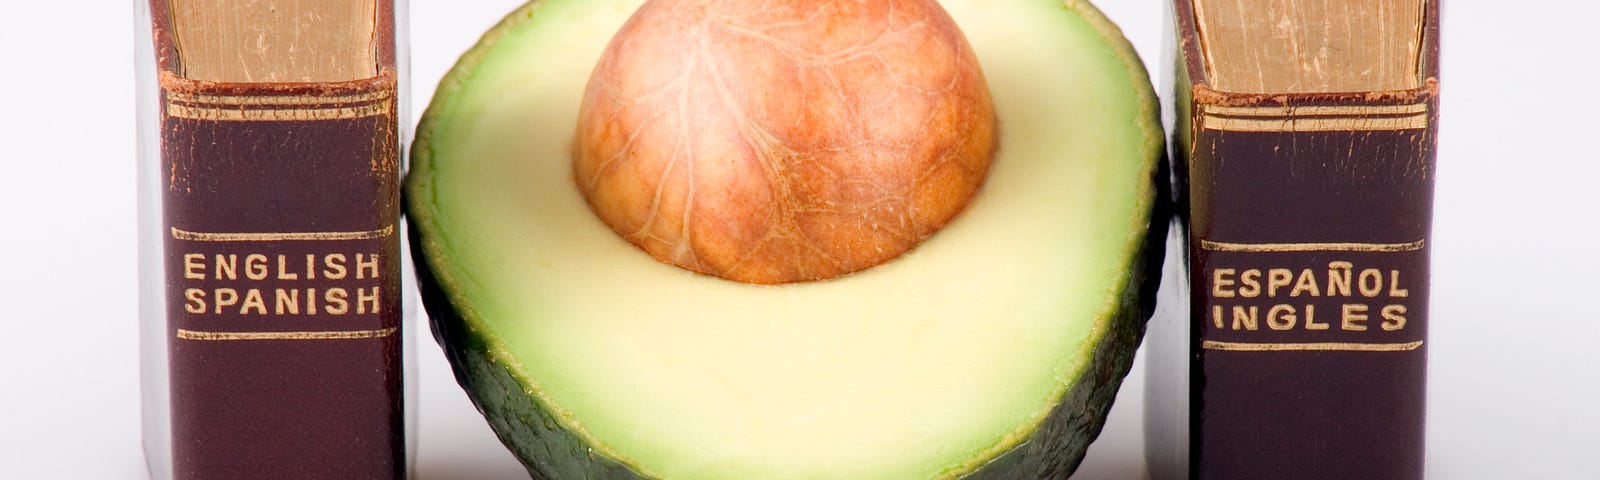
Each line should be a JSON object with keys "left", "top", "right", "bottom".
{"left": 1171, "top": 0, "right": 1438, "bottom": 100}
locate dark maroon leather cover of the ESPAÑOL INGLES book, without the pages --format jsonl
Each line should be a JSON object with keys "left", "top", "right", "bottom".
{"left": 1174, "top": 0, "right": 1438, "bottom": 480}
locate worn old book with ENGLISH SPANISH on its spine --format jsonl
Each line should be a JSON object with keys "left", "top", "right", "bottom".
{"left": 144, "top": 0, "right": 406, "bottom": 478}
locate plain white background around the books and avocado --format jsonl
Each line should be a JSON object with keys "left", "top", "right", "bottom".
{"left": 0, "top": 0, "right": 1600, "bottom": 480}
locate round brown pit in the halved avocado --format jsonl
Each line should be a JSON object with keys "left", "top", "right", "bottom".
{"left": 573, "top": 0, "right": 997, "bottom": 283}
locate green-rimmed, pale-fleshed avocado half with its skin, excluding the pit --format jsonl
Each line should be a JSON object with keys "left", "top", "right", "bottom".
{"left": 405, "top": 0, "right": 1166, "bottom": 480}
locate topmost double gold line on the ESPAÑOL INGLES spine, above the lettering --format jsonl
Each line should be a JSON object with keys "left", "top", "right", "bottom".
{"left": 1202, "top": 104, "right": 1429, "bottom": 131}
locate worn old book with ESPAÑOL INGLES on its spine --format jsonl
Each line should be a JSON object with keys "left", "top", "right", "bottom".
{"left": 1147, "top": 0, "right": 1438, "bottom": 478}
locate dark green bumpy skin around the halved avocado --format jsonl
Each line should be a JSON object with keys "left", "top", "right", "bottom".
{"left": 403, "top": 0, "right": 1174, "bottom": 480}
